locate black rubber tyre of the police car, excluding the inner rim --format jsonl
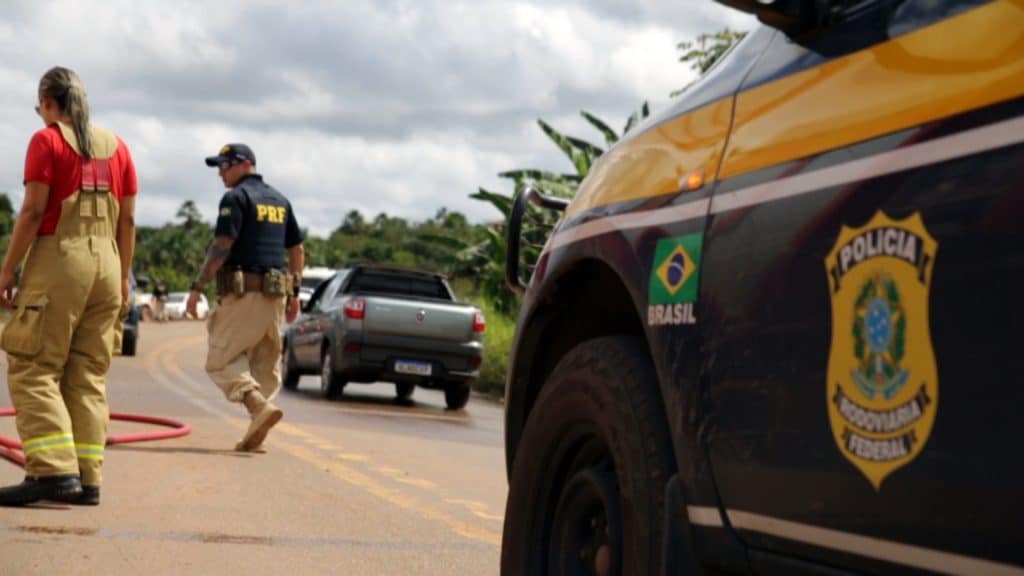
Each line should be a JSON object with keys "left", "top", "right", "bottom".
{"left": 502, "top": 336, "right": 675, "bottom": 575}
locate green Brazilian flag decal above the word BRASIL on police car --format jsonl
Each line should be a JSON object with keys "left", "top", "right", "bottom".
{"left": 647, "top": 234, "right": 703, "bottom": 304}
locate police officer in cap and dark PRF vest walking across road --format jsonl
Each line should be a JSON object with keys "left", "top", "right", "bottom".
{"left": 186, "top": 143, "right": 305, "bottom": 451}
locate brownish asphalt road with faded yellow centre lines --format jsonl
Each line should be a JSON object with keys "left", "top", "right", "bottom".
{"left": 0, "top": 321, "right": 507, "bottom": 576}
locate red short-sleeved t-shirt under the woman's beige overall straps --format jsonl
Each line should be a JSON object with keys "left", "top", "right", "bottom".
{"left": 25, "top": 124, "right": 138, "bottom": 236}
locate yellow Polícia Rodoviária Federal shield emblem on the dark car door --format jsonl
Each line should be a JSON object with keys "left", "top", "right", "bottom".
{"left": 825, "top": 212, "right": 939, "bottom": 490}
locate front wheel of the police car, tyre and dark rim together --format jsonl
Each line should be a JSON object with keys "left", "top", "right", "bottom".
{"left": 502, "top": 336, "right": 674, "bottom": 575}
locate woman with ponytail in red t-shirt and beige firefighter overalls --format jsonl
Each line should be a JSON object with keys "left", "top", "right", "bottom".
{"left": 0, "top": 68, "right": 137, "bottom": 505}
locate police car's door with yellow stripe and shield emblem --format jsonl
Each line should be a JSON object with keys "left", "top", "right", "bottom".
{"left": 698, "top": 2, "right": 1024, "bottom": 573}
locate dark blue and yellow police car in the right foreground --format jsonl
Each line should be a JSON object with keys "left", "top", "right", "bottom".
{"left": 502, "top": 0, "right": 1024, "bottom": 575}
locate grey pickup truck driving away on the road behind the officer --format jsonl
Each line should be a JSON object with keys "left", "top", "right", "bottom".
{"left": 281, "top": 265, "right": 486, "bottom": 410}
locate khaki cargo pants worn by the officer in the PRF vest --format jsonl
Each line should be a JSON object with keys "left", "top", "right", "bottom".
{"left": 206, "top": 292, "right": 285, "bottom": 402}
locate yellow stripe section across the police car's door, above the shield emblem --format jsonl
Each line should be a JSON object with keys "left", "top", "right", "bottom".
{"left": 719, "top": 1, "right": 1024, "bottom": 179}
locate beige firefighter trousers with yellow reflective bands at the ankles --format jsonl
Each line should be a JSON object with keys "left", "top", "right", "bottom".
{"left": 0, "top": 191, "right": 122, "bottom": 486}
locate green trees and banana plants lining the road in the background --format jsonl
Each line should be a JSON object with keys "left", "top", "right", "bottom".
{"left": 0, "top": 29, "right": 744, "bottom": 393}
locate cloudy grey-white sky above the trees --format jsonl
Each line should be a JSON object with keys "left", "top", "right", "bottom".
{"left": 0, "top": 0, "right": 754, "bottom": 235}
